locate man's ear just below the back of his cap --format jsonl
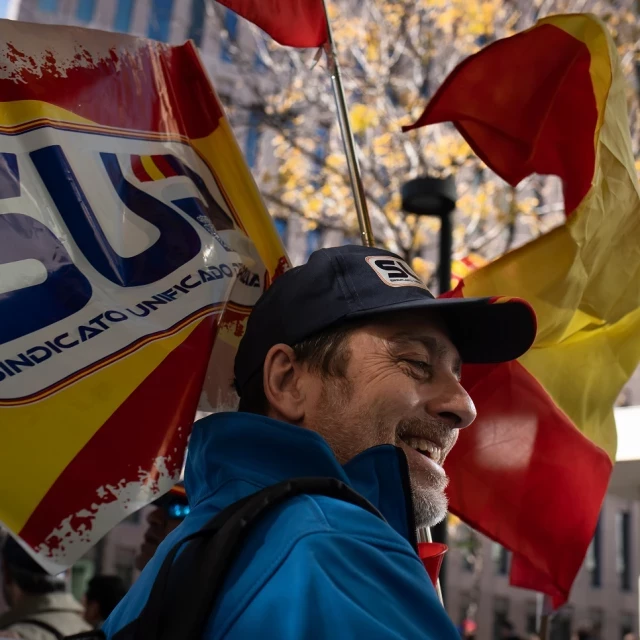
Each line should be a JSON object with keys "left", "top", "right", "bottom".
{"left": 262, "top": 344, "right": 305, "bottom": 424}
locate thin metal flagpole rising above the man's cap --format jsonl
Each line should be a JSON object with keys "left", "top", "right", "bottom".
{"left": 322, "top": 0, "right": 375, "bottom": 247}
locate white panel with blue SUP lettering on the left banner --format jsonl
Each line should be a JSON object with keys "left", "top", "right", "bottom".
{"left": 0, "top": 125, "right": 264, "bottom": 401}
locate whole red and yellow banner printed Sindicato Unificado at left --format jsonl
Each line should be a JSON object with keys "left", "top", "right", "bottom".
{"left": 0, "top": 21, "right": 287, "bottom": 571}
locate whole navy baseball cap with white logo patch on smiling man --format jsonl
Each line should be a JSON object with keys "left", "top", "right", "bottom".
{"left": 234, "top": 245, "right": 536, "bottom": 395}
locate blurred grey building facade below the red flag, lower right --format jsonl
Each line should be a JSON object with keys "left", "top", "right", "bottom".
{"left": 445, "top": 494, "right": 640, "bottom": 640}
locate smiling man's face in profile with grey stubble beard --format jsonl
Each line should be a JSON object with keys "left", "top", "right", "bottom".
{"left": 303, "top": 313, "right": 476, "bottom": 526}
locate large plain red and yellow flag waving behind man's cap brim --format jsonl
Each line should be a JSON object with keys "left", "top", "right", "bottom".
{"left": 407, "top": 14, "right": 640, "bottom": 606}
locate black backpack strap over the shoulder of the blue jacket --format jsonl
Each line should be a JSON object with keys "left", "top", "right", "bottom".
{"left": 125, "top": 478, "right": 384, "bottom": 640}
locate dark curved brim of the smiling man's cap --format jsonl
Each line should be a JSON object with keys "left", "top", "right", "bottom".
{"left": 349, "top": 298, "right": 537, "bottom": 364}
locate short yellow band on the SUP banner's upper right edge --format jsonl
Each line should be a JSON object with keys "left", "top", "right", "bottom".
{"left": 191, "top": 118, "right": 286, "bottom": 275}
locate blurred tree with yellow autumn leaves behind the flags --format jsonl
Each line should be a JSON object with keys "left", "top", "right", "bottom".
{"left": 256, "top": 0, "right": 640, "bottom": 280}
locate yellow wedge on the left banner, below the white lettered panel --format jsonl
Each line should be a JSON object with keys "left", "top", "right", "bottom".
{"left": 0, "top": 320, "right": 203, "bottom": 532}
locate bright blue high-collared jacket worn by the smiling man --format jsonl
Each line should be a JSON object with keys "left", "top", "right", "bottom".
{"left": 104, "top": 413, "right": 459, "bottom": 640}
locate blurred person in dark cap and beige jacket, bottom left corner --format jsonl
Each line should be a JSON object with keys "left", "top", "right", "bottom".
{"left": 0, "top": 538, "right": 91, "bottom": 640}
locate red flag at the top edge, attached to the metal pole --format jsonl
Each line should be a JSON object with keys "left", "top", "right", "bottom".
{"left": 218, "top": 0, "right": 327, "bottom": 49}
